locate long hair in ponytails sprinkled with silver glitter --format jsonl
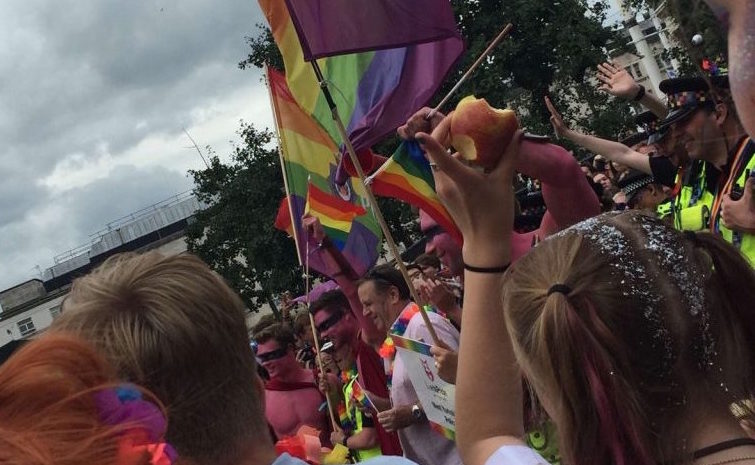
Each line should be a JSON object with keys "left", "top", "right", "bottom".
{"left": 504, "top": 212, "right": 755, "bottom": 465}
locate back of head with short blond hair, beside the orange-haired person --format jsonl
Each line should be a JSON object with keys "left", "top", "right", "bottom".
{"left": 54, "top": 252, "right": 268, "bottom": 464}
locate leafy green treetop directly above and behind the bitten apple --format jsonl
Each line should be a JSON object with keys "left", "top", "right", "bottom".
{"left": 440, "top": 0, "right": 631, "bottom": 142}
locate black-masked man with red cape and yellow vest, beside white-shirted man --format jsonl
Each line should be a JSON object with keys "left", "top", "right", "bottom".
{"left": 309, "top": 289, "right": 403, "bottom": 460}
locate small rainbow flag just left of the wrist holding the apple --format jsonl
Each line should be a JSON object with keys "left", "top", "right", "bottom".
{"left": 368, "top": 141, "right": 462, "bottom": 244}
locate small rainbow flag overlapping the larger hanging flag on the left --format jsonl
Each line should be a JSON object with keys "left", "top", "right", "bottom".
{"left": 304, "top": 184, "right": 367, "bottom": 250}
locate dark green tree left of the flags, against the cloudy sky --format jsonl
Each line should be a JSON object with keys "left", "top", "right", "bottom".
{"left": 186, "top": 121, "right": 303, "bottom": 310}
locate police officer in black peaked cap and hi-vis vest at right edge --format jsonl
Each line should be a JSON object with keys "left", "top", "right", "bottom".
{"left": 660, "top": 76, "right": 755, "bottom": 264}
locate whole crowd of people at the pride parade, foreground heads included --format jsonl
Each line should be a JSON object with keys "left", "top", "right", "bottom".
{"left": 0, "top": 0, "right": 755, "bottom": 465}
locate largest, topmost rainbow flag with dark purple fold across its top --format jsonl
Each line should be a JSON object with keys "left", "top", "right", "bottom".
{"left": 259, "top": 0, "right": 464, "bottom": 184}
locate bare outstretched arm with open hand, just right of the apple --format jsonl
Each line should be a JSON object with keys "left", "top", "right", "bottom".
{"left": 545, "top": 97, "right": 652, "bottom": 174}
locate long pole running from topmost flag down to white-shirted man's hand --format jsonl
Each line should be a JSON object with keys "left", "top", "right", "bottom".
{"left": 311, "top": 60, "right": 440, "bottom": 345}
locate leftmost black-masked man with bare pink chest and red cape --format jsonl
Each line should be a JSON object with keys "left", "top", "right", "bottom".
{"left": 254, "top": 323, "right": 331, "bottom": 446}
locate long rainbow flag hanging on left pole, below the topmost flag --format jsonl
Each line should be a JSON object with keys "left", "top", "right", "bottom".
{"left": 267, "top": 68, "right": 383, "bottom": 275}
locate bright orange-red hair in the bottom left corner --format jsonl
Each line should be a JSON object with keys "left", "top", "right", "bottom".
{"left": 0, "top": 334, "right": 159, "bottom": 465}
